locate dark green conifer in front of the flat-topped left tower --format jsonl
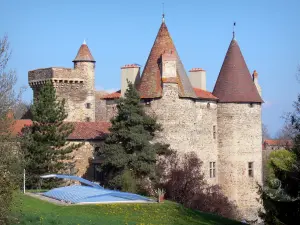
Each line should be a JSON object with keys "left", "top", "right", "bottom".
{"left": 21, "top": 82, "right": 80, "bottom": 188}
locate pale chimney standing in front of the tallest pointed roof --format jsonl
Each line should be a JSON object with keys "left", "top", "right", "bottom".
{"left": 161, "top": 50, "right": 177, "bottom": 81}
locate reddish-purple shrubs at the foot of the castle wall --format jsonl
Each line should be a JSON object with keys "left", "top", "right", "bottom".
{"left": 162, "top": 152, "right": 237, "bottom": 218}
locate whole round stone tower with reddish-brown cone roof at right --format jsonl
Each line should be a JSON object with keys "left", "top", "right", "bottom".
{"left": 213, "top": 34, "right": 263, "bottom": 221}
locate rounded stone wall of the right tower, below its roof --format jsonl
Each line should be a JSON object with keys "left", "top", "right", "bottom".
{"left": 218, "top": 103, "right": 262, "bottom": 220}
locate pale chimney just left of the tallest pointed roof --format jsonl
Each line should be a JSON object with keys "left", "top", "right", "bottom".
{"left": 121, "top": 64, "right": 140, "bottom": 97}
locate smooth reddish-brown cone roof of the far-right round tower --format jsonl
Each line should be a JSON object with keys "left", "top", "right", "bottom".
{"left": 213, "top": 39, "right": 263, "bottom": 103}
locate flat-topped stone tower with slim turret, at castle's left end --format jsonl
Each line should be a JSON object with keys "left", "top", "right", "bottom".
{"left": 28, "top": 42, "right": 95, "bottom": 121}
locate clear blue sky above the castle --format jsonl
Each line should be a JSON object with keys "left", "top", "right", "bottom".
{"left": 0, "top": 0, "right": 300, "bottom": 134}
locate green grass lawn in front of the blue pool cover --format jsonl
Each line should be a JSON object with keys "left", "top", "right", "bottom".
{"left": 14, "top": 194, "right": 244, "bottom": 225}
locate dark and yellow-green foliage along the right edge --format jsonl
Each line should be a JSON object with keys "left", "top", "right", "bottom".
{"left": 260, "top": 95, "right": 300, "bottom": 225}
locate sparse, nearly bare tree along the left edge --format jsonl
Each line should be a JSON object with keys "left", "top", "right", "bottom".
{"left": 0, "top": 36, "right": 22, "bottom": 225}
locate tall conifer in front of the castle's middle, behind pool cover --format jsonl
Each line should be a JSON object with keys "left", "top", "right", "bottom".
{"left": 98, "top": 82, "right": 169, "bottom": 191}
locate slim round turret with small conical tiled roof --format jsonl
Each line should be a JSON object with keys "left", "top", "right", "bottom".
{"left": 73, "top": 41, "right": 96, "bottom": 122}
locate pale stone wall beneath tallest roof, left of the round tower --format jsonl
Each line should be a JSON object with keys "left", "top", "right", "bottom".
{"left": 145, "top": 83, "right": 218, "bottom": 184}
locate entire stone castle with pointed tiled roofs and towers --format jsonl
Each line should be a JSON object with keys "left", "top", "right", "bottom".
{"left": 28, "top": 19, "right": 263, "bottom": 220}
